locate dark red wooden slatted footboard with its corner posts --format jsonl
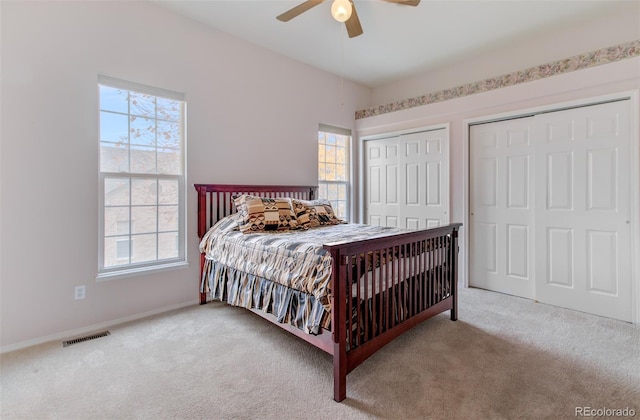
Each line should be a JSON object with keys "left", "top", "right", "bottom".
{"left": 325, "top": 223, "right": 461, "bottom": 401}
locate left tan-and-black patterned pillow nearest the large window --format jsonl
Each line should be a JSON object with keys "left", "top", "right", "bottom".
{"left": 233, "top": 194, "right": 298, "bottom": 233}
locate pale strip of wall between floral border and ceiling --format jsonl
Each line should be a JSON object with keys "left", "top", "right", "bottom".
{"left": 373, "top": 1, "right": 640, "bottom": 105}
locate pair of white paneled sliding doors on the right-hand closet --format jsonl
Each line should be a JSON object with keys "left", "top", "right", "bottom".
{"left": 469, "top": 101, "right": 633, "bottom": 321}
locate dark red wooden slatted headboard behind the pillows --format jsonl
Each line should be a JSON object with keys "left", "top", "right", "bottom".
{"left": 194, "top": 184, "right": 318, "bottom": 238}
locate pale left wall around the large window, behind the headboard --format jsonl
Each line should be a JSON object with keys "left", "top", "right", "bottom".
{"left": 0, "top": 1, "right": 371, "bottom": 351}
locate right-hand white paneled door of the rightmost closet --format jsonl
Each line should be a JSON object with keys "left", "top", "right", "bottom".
{"left": 536, "top": 101, "right": 632, "bottom": 321}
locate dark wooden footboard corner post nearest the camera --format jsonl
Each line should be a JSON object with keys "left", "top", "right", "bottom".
{"left": 331, "top": 250, "right": 347, "bottom": 402}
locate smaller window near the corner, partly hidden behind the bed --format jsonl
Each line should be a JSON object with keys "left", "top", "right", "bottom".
{"left": 318, "top": 124, "right": 351, "bottom": 219}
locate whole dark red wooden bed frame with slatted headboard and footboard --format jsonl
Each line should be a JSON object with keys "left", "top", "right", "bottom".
{"left": 195, "top": 184, "right": 461, "bottom": 402}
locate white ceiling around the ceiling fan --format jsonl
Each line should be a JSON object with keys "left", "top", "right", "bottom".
{"left": 152, "top": 0, "right": 622, "bottom": 87}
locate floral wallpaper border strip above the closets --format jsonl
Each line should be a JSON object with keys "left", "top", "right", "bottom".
{"left": 356, "top": 40, "right": 640, "bottom": 120}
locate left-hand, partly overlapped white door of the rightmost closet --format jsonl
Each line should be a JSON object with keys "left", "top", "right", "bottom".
{"left": 469, "top": 117, "right": 535, "bottom": 299}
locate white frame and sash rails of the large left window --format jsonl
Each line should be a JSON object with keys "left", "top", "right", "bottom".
{"left": 96, "top": 75, "right": 188, "bottom": 281}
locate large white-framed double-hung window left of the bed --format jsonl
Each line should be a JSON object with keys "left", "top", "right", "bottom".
{"left": 98, "top": 76, "right": 186, "bottom": 277}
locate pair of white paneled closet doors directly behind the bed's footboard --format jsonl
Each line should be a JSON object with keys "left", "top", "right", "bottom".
{"left": 364, "top": 128, "right": 449, "bottom": 230}
